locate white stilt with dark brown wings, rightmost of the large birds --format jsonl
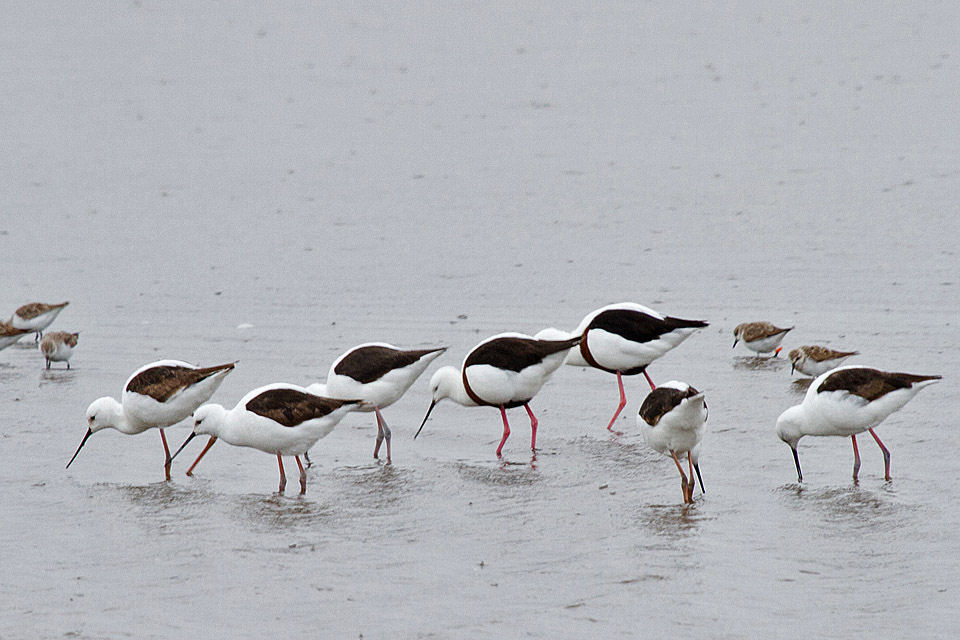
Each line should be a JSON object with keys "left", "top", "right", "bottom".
{"left": 777, "top": 366, "right": 940, "bottom": 482}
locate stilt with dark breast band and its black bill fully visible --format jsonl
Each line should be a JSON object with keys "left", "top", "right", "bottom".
{"left": 413, "top": 333, "right": 580, "bottom": 458}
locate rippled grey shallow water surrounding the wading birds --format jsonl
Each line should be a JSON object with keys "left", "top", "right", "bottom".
{"left": 0, "top": 0, "right": 960, "bottom": 638}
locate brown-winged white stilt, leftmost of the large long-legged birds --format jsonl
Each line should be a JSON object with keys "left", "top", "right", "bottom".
{"left": 67, "top": 360, "right": 236, "bottom": 480}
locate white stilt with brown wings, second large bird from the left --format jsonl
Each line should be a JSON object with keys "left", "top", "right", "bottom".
{"left": 173, "top": 383, "right": 361, "bottom": 494}
